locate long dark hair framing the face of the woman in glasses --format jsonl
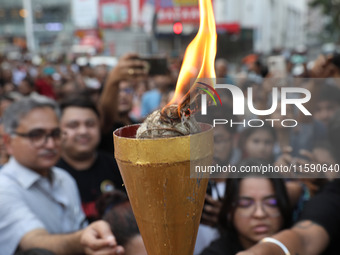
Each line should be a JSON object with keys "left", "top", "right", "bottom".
{"left": 219, "top": 159, "right": 292, "bottom": 232}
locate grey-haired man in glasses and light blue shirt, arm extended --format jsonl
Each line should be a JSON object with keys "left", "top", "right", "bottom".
{"left": 0, "top": 98, "right": 123, "bottom": 255}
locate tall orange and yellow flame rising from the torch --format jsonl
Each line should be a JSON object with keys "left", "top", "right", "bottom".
{"left": 168, "top": 0, "right": 217, "bottom": 105}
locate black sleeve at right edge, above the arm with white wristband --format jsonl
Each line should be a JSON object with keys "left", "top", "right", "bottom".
{"left": 300, "top": 179, "right": 340, "bottom": 255}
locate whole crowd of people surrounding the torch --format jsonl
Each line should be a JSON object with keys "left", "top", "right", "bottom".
{"left": 0, "top": 47, "right": 340, "bottom": 255}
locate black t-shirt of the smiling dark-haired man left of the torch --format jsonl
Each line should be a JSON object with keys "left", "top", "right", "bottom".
{"left": 57, "top": 152, "right": 125, "bottom": 221}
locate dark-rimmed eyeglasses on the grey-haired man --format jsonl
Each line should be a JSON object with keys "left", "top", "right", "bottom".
{"left": 14, "top": 128, "right": 61, "bottom": 147}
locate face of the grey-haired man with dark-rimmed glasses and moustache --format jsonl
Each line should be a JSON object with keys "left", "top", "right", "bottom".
{"left": 6, "top": 107, "right": 60, "bottom": 174}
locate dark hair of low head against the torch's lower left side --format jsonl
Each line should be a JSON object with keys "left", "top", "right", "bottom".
{"left": 96, "top": 190, "right": 140, "bottom": 246}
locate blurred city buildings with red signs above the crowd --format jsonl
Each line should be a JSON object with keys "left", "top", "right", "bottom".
{"left": 0, "top": 0, "right": 308, "bottom": 56}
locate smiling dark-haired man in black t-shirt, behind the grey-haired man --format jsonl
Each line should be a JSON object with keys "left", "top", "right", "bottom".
{"left": 57, "top": 97, "right": 124, "bottom": 221}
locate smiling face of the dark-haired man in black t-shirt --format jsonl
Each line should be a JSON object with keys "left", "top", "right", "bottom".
{"left": 60, "top": 106, "right": 100, "bottom": 158}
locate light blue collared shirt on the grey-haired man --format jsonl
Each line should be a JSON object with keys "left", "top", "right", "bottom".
{"left": 0, "top": 158, "right": 87, "bottom": 255}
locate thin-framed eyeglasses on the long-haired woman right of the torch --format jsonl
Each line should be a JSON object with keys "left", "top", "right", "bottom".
{"left": 236, "top": 197, "right": 280, "bottom": 217}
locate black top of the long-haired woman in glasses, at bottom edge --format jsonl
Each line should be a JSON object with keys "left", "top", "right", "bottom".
{"left": 200, "top": 231, "right": 244, "bottom": 255}
